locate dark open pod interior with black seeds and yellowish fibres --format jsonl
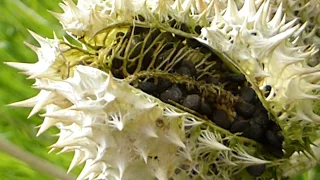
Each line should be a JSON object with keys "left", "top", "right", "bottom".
{"left": 103, "top": 24, "right": 284, "bottom": 176}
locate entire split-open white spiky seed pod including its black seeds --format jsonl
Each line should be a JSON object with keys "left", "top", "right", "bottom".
{"left": 7, "top": 0, "right": 320, "bottom": 180}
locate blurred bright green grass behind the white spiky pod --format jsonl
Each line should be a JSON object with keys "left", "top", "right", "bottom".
{"left": 0, "top": 0, "right": 320, "bottom": 180}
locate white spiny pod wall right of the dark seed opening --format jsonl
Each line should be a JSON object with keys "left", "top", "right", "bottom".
{"left": 202, "top": 1, "right": 320, "bottom": 146}
